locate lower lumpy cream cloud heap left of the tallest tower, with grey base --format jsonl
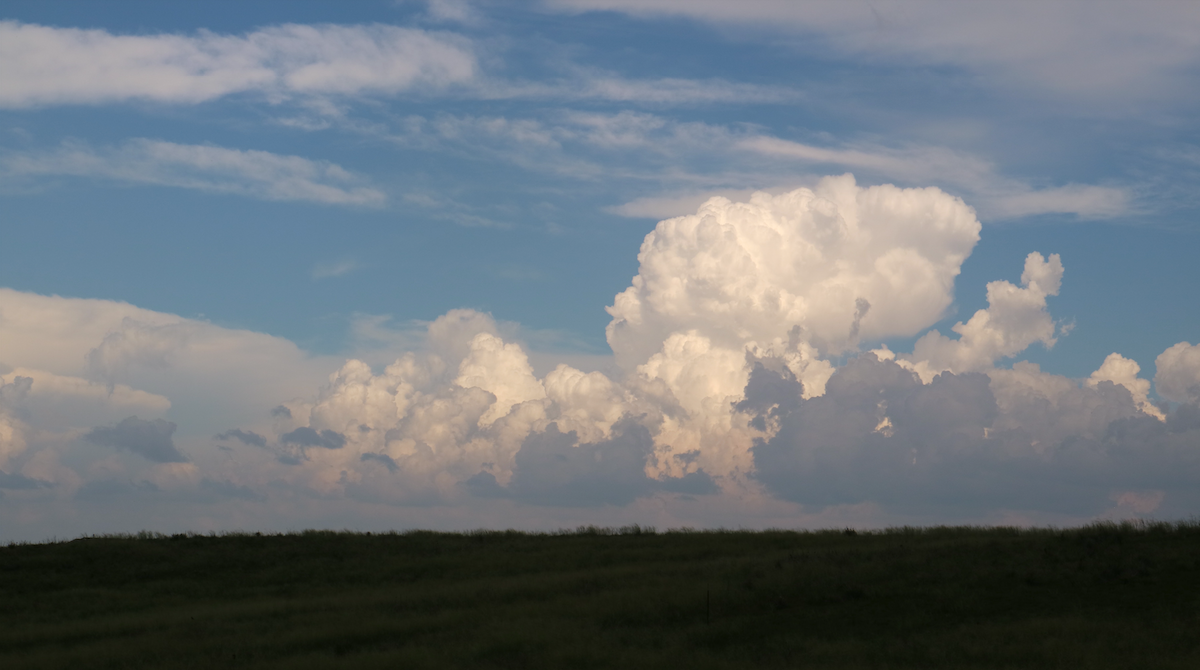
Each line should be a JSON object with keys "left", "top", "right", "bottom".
{"left": 188, "top": 310, "right": 715, "bottom": 507}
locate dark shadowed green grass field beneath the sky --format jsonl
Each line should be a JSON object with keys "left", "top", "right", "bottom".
{"left": 0, "top": 524, "right": 1200, "bottom": 669}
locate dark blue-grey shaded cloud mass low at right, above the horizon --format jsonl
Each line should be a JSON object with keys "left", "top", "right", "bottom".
{"left": 746, "top": 353, "right": 1200, "bottom": 519}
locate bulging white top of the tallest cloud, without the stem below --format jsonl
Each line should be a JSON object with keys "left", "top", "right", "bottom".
{"left": 607, "top": 175, "right": 980, "bottom": 374}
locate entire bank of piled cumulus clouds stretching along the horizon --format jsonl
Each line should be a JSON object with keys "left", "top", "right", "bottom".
{"left": 0, "top": 175, "right": 1200, "bottom": 530}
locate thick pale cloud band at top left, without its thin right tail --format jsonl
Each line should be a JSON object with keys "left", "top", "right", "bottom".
{"left": 0, "top": 20, "right": 476, "bottom": 108}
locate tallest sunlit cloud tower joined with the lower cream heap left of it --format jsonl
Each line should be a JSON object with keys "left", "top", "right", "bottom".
{"left": 246, "top": 175, "right": 980, "bottom": 504}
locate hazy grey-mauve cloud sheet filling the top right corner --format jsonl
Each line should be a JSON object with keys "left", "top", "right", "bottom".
{"left": 546, "top": 0, "right": 1200, "bottom": 104}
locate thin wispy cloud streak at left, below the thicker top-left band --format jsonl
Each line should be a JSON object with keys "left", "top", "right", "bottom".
{"left": 0, "top": 139, "right": 386, "bottom": 207}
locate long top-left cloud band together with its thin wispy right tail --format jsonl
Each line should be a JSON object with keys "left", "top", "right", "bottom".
{"left": 0, "top": 20, "right": 800, "bottom": 111}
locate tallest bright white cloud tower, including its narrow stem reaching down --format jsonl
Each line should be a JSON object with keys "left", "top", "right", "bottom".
{"left": 597, "top": 175, "right": 980, "bottom": 486}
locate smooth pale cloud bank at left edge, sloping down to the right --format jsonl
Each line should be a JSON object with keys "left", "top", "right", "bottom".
{"left": 0, "top": 288, "right": 341, "bottom": 436}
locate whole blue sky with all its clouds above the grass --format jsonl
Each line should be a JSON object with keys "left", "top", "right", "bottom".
{"left": 0, "top": 0, "right": 1200, "bottom": 542}
